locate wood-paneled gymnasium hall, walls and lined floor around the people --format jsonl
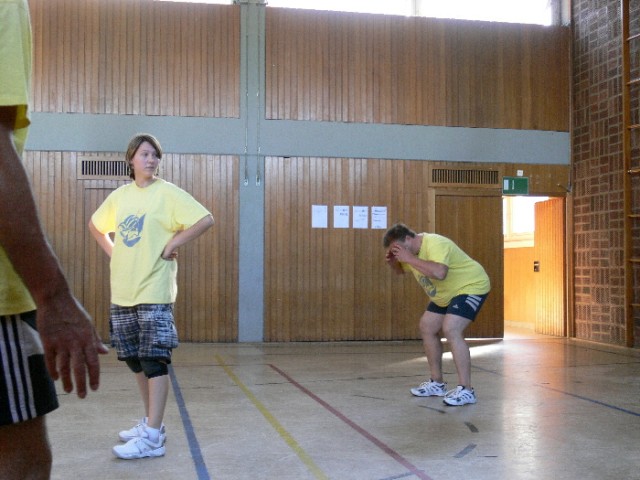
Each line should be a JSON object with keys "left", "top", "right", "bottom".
{"left": 17, "top": 0, "right": 640, "bottom": 480}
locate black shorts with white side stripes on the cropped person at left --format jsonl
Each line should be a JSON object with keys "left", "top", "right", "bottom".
{"left": 0, "top": 311, "right": 58, "bottom": 425}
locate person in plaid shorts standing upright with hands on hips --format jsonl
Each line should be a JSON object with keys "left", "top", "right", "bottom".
{"left": 89, "top": 134, "right": 213, "bottom": 460}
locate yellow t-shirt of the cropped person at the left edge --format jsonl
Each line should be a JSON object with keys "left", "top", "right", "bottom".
{"left": 0, "top": 0, "right": 35, "bottom": 315}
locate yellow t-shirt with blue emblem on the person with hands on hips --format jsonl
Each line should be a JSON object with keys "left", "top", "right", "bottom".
{"left": 91, "top": 179, "right": 210, "bottom": 307}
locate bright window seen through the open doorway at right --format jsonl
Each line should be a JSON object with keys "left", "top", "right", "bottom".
{"left": 502, "top": 197, "right": 549, "bottom": 248}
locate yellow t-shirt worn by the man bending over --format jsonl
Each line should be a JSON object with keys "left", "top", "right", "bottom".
{"left": 402, "top": 233, "right": 491, "bottom": 307}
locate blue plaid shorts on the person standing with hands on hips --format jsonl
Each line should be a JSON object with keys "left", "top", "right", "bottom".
{"left": 109, "top": 303, "right": 178, "bottom": 363}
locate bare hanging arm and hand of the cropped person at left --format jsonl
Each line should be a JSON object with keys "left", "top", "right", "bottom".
{"left": 0, "top": 107, "right": 107, "bottom": 398}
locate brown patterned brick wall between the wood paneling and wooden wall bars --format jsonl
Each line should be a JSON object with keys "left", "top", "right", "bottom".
{"left": 572, "top": 0, "right": 626, "bottom": 345}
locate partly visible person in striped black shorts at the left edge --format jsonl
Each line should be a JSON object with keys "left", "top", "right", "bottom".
{"left": 0, "top": 0, "right": 108, "bottom": 480}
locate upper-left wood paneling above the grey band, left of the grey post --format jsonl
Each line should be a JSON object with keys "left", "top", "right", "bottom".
{"left": 29, "top": 0, "right": 240, "bottom": 118}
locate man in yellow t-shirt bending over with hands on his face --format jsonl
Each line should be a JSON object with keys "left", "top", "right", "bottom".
{"left": 383, "top": 223, "right": 491, "bottom": 406}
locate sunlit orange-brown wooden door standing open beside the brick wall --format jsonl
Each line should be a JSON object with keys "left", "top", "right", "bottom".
{"left": 533, "top": 198, "right": 566, "bottom": 336}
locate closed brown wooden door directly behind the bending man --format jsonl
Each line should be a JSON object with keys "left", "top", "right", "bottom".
{"left": 435, "top": 192, "right": 504, "bottom": 338}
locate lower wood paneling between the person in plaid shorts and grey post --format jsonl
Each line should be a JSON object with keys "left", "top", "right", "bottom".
{"left": 163, "top": 155, "right": 238, "bottom": 342}
